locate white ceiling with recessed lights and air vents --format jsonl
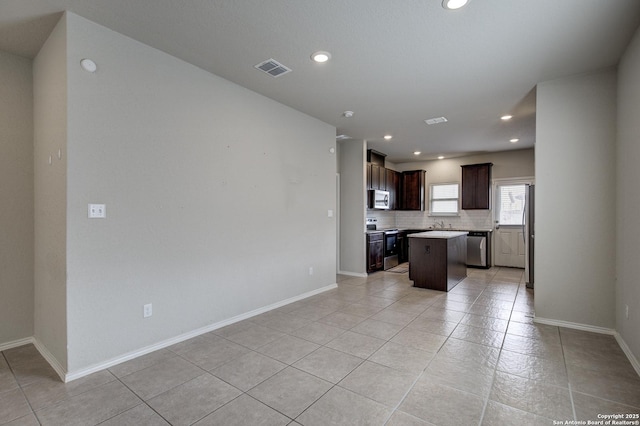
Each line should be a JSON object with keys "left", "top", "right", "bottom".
{"left": 0, "top": 0, "right": 640, "bottom": 162}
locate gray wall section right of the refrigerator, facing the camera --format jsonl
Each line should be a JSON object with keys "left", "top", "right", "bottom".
{"left": 535, "top": 70, "right": 616, "bottom": 329}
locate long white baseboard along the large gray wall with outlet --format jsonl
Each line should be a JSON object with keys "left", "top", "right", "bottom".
{"left": 63, "top": 283, "right": 338, "bottom": 382}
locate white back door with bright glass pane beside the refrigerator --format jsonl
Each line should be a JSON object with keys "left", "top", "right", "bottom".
{"left": 494, "top": 182, "right": 526, "bottom": 268}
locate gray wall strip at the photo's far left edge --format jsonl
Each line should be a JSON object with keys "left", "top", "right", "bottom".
{"left": 0, "top": 52, "right": 33, "bottom": 346}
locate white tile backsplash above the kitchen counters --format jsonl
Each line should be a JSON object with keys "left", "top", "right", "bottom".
{"left": 367, "top": 210, "right": 493, "bottom": 230}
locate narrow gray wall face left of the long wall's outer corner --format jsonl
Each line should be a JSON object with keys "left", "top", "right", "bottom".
{"left": 33, "top": 15, "right": 67, "bottom": 370}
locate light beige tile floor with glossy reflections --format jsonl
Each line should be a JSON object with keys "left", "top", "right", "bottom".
{"left": 0, "top": 268, "right": 640, "bottom": 426}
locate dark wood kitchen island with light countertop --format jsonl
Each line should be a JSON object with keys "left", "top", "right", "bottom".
{"left": 407, "top": 231, "right": 467, "bottom": 291}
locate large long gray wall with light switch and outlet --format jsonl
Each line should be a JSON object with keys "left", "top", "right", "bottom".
{"left": 36, "top": 14, "right": 337, "bottom": 374}
